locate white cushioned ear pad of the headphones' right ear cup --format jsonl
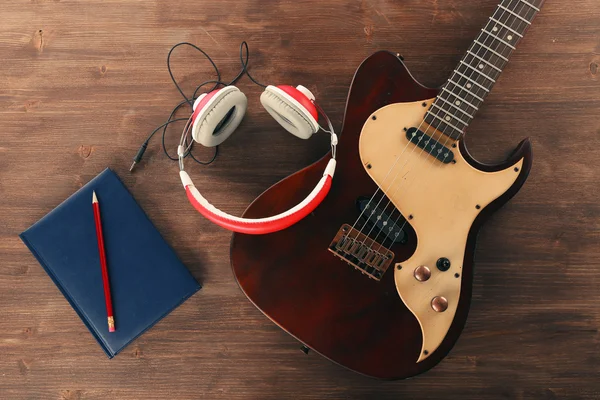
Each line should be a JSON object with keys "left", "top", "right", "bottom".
{"left": 260, "top": 86, "right": 317, "bottom": 139}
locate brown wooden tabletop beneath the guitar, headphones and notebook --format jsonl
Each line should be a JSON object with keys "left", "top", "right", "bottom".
{"left": 0, "top": 0, "right": 600, "bottom": 399}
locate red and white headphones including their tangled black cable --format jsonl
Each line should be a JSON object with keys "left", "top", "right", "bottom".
{"left": 129, "top": 42, "right": 338, "bottom": 234}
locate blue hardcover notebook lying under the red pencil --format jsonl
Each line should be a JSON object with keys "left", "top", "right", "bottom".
{"left": 20, "top": 169, "right": 200, "bottom": 358}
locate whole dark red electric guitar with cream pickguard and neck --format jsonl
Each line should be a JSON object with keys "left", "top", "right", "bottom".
{"left": 231, "top": 0, "right": 544, "bottom": 379}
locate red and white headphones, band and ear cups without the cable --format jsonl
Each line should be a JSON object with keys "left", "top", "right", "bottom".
{"left": 177, "top": 85, "right": 338, "bottom": 235}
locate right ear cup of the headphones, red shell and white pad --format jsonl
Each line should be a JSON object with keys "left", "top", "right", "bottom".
{"left": 260, "top": 85, "right": 319, "bottom": 139}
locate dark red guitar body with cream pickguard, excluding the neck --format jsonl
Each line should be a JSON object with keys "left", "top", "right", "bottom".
{"left": 231, "top": 52, "right": 532, "bottom": 379}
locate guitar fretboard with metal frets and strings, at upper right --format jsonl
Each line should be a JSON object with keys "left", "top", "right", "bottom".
{"left": 425, "top": 0, "right": 544, "bottom": 139}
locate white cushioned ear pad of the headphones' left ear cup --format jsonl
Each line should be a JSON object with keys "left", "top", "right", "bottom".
{"left": 192, "top": 86, "right": 248, "bottom": 147}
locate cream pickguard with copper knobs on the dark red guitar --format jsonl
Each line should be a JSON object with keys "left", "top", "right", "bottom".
{"left": 359, "top": 99, "right": 523, "bottom": 362}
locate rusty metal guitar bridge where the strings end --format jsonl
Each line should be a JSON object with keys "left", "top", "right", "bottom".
{"left": 328, "top": 224, "right": 395, "bottom": 281}
